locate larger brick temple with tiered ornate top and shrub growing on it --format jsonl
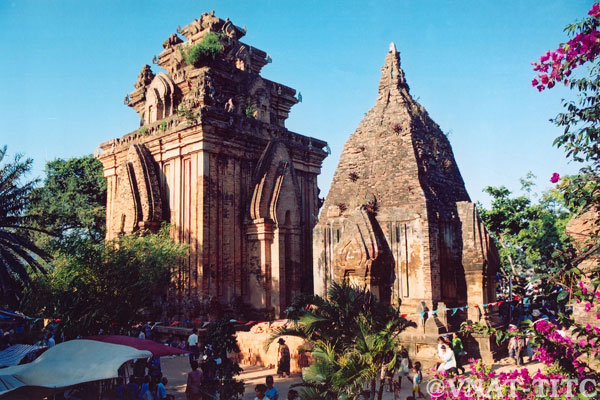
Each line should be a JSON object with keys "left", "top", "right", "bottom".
{"left": 99, "top": 13, "right": 327, "bottom": 315}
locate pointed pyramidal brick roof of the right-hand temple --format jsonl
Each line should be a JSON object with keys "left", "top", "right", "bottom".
{"left": 321, "top": 43, "right": 469, "bottom": 221}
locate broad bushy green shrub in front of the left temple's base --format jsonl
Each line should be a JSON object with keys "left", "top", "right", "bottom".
{"left": 22, "top": 226, "right": 187, "bottom": 337}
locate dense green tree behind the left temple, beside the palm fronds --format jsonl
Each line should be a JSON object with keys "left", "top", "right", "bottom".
{"left": 27, "top": 155, "right": 106, "bottom": 252}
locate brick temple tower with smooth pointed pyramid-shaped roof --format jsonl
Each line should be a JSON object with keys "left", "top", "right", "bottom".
{"left": 313, "top": 44, "right": 499, "bottom": 360}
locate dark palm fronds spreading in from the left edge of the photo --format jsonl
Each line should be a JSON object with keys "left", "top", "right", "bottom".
{"left": 0, "top": 146, "right": 46, "bottom": 305}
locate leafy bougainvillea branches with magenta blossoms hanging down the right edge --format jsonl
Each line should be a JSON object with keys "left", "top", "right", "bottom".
{"left": 532, "top": 3, "right": 600, "bottom": 306}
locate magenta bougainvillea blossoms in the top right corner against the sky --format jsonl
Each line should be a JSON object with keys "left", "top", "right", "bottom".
{"left": 531, "top": 3, "right": 600, "bottom": 92}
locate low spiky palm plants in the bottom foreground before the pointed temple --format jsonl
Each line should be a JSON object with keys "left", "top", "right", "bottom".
{"left": 271, "top": 282, "right": 410, "bottom": 399}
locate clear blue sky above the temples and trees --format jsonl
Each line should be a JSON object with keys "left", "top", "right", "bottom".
{"left": 0, "top": 0, "right": 593, "bottom": 203}
